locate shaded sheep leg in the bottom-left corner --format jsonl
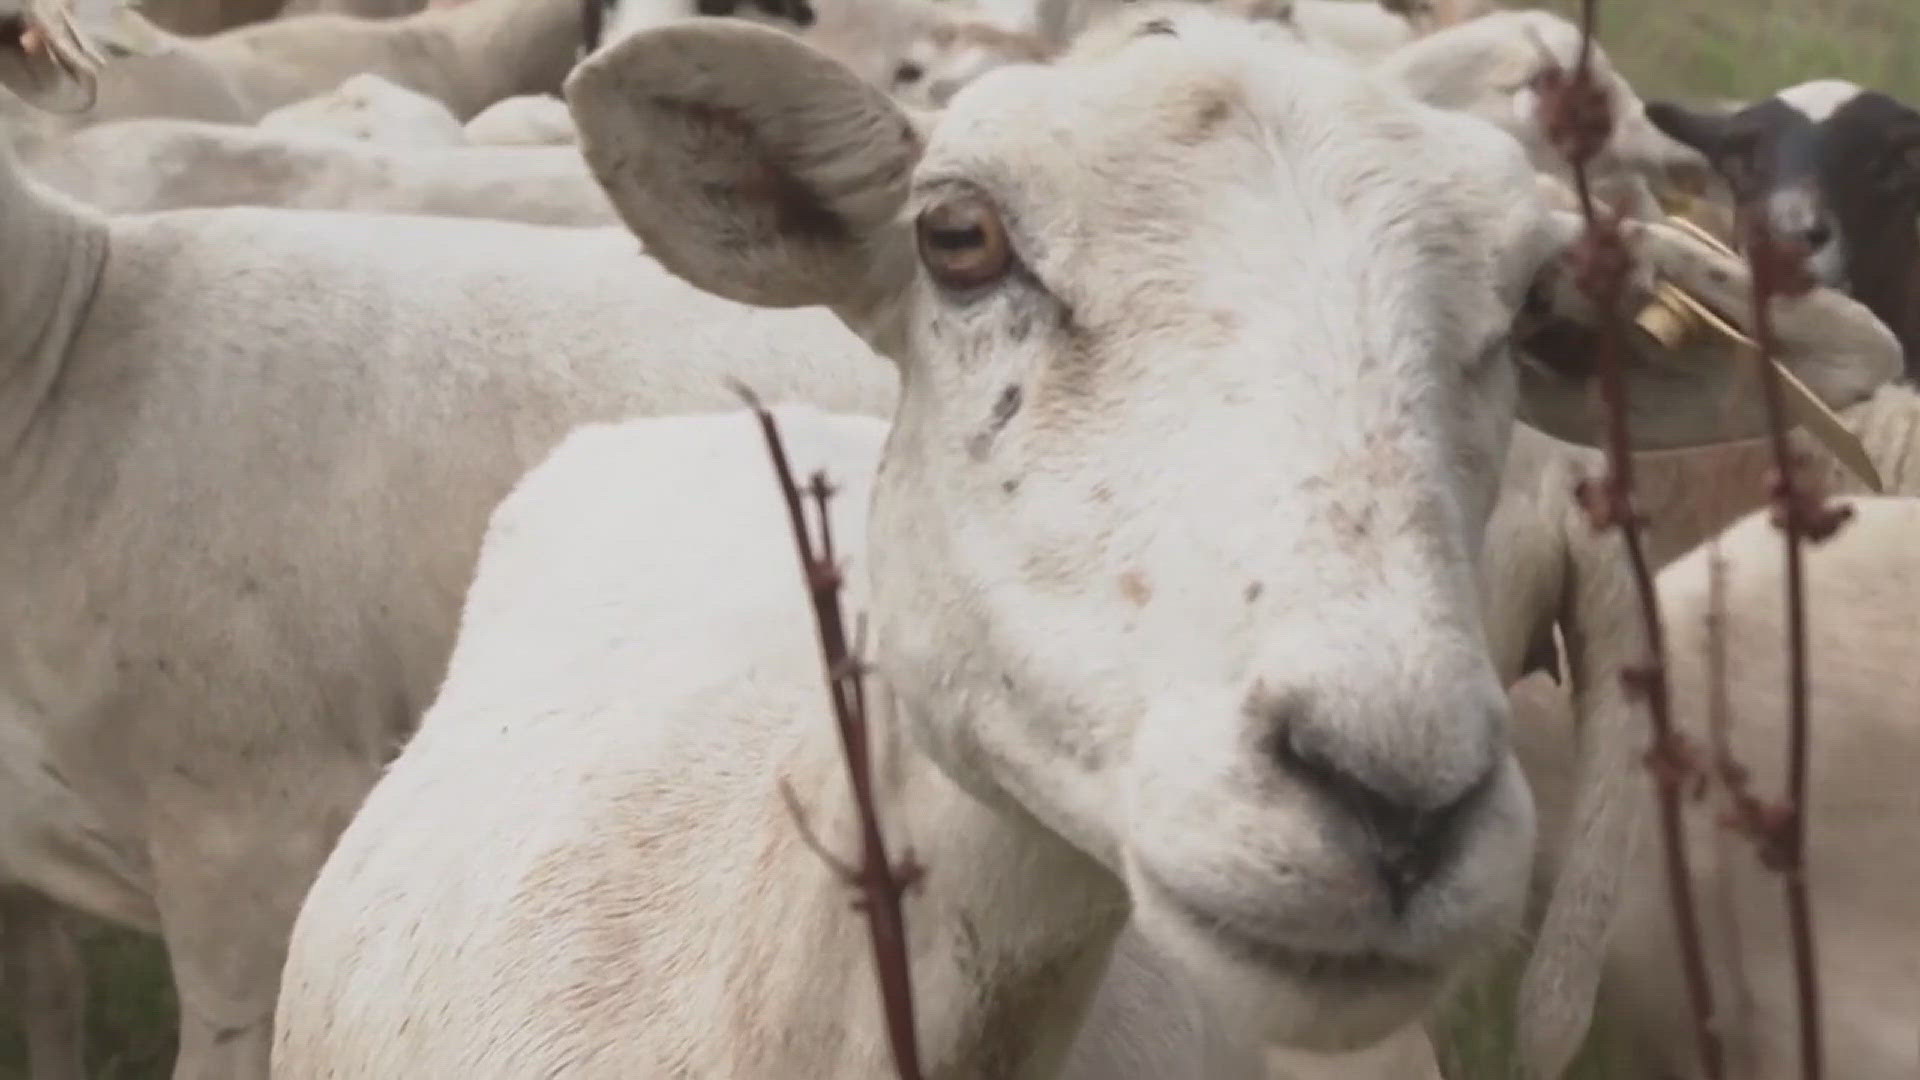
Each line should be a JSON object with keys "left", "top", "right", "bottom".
{"left": 0, "top": 888, "right": 86, "bottom": 1080}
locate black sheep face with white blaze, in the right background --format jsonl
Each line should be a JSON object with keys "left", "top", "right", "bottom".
{"left": 1647, "top": 79, "right": 1920, "bottom": 365}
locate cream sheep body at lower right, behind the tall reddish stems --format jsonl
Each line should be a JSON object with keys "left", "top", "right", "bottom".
{"left": 1519, "top": 496, "right": 1920, "bottom": 1080}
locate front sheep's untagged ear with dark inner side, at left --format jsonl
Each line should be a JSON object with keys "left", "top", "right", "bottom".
{"left": 564, "top": 19, "right": 922, "bottom": 315}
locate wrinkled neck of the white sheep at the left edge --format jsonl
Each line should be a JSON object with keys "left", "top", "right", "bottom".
{"left": 0, "top": 144, "right": 108, "bottom": 452}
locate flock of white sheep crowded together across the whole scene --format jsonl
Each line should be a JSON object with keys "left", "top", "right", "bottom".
{"left": 0, "top": 0, "right": 1920, "bottom": 1080}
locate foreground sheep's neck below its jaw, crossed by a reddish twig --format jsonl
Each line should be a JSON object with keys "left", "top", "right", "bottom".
{"left": 714, "top": 680, "right": 1127, "bottom": 1080}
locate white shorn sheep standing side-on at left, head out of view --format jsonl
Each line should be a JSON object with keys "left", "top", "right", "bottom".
{"left": 0, "top": 12, "right": 897, "bottom": 1080}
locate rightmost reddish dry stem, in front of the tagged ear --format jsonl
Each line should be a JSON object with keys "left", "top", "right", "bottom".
{"left": 1745, "top": 213, "right": 1845, "bottom": 1080}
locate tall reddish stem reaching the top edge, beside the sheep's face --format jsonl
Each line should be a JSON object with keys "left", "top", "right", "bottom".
{"left": 1538, "top": 0, "right": 1726, "bottom": 1080}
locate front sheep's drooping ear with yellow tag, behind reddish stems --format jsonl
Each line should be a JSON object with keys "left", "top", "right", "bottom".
{"left": 1515, "top": 209, "right": 1901, "bottom": 450}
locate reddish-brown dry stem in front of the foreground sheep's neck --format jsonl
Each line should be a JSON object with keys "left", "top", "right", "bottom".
{"left": 735, "top": 386, "right": 925, "bottom": 1080}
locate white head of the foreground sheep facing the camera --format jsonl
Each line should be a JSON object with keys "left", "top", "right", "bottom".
{"left": 566, "top": 6, "right": 1884, "bottom": 1049}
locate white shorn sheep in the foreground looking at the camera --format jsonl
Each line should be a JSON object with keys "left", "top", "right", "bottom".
{"left": 275, "top": 4, "right": 1893, "bottom": 1080}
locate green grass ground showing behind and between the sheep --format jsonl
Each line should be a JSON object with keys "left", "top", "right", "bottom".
{"left": 0, "top": 0, "right": 1920, "bottom": 1080}
